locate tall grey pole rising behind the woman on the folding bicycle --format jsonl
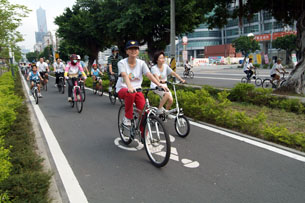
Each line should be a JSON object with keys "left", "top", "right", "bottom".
{"left": 170, "top": 0, "right": 176, "bottom": 71}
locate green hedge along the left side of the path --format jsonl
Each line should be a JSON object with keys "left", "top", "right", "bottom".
{"left": 0, "top": 71, "right": 51, "bottom": 202}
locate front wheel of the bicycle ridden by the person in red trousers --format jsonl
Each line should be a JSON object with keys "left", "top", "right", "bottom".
{"left": 144, "top": 116, "right": 171, "bottom": 168}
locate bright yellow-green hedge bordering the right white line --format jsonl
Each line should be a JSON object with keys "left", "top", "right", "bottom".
{"left": 148, "top": 89, "right": 305, "bottom": 151}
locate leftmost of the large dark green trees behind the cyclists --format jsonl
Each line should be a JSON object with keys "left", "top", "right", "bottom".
{"left": 55, "top": 0, "right": 110, "bottom": 64}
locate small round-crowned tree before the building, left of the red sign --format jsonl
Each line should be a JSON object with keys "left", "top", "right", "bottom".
{"left": 232, "top": 36, "right": 260, "bottom": 67}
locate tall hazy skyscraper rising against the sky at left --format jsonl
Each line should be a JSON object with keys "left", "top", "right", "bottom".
{"left": 35, "top": 7, "right": 48, "bottom": 43}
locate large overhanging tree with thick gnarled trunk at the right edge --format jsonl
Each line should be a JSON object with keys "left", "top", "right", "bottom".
{"left": 202, "top": 0, "right": 305, "bottom": 94}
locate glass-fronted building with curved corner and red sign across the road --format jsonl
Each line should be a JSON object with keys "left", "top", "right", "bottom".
{"left": 166, "top": 8, "right": 296, "bottom": 62}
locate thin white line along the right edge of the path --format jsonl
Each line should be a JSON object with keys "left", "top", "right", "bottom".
{"left": 190, "top": 121, "right": 305, "bottom": 162}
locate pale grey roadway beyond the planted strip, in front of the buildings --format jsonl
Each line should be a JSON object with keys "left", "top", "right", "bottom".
{"left": 177, "top": 66, "right": 270, "bottom": 88}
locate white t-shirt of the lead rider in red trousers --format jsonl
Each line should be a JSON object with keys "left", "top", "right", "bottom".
{"left": 116, "top": 58, "right": 149, "bottom": 92}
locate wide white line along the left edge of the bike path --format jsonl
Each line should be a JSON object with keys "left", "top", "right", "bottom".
{"left": 22, "top": 74, "right": 88, "bottom": 203}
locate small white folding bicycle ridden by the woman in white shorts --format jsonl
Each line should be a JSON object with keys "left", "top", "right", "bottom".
{"left": 159, "top": 81, "right": 190, "bottom": 138}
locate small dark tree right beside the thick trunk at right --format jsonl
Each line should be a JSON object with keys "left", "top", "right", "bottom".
{"left": 272, "top": 35, "right": 297, "bottom": 67}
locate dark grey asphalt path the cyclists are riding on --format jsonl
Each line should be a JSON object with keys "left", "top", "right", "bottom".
{"left": 25, "top": 76, "right": 305, "bottom": 203}
